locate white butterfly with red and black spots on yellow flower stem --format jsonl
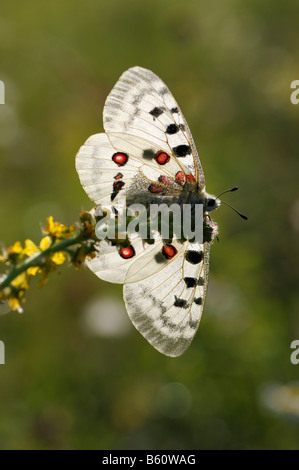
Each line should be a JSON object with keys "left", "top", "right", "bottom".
{"left": 76, "top": 67, "right": 229, "bottom": 357}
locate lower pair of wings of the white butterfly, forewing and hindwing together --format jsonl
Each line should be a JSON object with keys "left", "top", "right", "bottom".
{"left": 87, "top": 235, "right": 209, "bottom": 357}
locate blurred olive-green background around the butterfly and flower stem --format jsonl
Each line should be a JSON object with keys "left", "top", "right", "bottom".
{"left": 0, "top": 0, "right": 299, "bottom": 449}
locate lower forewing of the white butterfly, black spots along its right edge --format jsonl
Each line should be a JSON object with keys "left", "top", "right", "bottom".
{"left": 124, "top": 242, "right": 209, "bottom": 357}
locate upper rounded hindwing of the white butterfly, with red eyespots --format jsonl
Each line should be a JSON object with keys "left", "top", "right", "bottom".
{"left": 76, "top": 134, "right": 186, "bottom": 206}
